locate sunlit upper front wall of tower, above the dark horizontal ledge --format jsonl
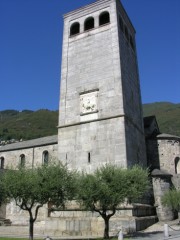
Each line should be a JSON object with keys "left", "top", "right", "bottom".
{"left": 59, "top": 0, "right": 124, "bottom": 126}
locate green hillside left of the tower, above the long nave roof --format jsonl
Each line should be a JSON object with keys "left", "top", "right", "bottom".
{"left": 0, "top": 109, "right": 58, "bottom": 140}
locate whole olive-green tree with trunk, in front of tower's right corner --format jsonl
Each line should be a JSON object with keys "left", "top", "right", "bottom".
{"left": 78, "top": 165, "right": 149, "bottom": 239}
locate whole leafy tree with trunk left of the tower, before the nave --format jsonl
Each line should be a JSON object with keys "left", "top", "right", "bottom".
{"left": 0, "top": 164, "right": 75, "bottom": 239}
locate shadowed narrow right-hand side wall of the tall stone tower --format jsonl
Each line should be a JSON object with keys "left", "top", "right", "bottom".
{"left": 118, "top": 0, "right": 147, "bottom": 166}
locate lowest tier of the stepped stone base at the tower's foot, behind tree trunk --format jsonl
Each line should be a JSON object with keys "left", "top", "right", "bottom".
{"left": 38, "top": 216, "right": 158, "bottom": 237}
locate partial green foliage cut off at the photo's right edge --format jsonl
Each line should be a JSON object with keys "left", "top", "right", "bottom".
{"left": 162, "top": 189, "right": 180, "bottom": 220}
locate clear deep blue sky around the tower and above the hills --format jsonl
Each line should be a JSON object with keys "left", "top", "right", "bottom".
{"left": 0, "top": 0, "right": 180, "bottom": 111}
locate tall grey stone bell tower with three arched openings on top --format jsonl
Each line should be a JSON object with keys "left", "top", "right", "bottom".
{"left": 58, "top": 0, "right": 146, "bottom": 172}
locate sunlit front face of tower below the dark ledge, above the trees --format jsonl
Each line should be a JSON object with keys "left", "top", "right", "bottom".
{"left": 59, "top": 118, "right": 127, "bottom": 172}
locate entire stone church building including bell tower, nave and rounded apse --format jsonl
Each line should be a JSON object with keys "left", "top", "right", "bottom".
{"left": 0, "top": 0, "right": 180, "bottom": 236}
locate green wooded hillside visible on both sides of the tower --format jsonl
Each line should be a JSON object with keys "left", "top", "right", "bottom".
{"left": 0, "top": 102, "right": 180, "bottom": 141}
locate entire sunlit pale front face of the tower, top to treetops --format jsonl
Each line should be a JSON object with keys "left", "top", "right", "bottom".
{"left": 58, "top": 0, "right": 126, "bottom": 171}
